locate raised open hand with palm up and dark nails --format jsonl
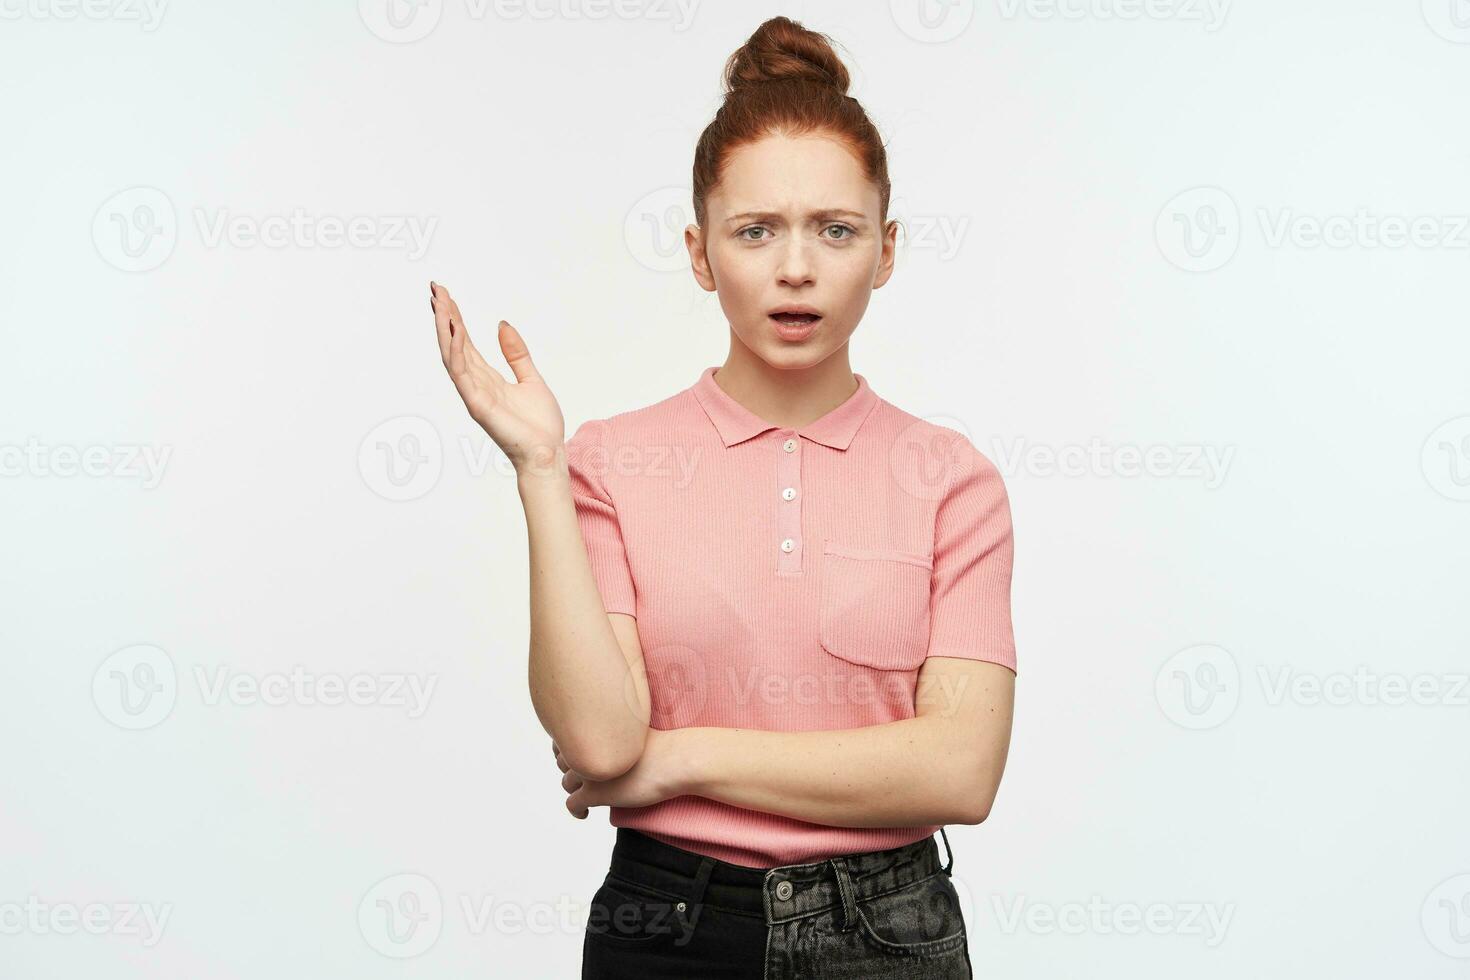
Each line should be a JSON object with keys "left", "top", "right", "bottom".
{"left": 429, "top": 282, "right": 566, "bottom": 472}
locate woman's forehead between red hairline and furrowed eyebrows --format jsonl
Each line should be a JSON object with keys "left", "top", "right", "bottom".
{"left": 709, "top": 134, "right": 879, "bottom": 215}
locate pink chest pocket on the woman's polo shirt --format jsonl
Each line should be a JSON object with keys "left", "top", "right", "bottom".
{"left": 819, "top": 541, "right": 933, "bottom": 670}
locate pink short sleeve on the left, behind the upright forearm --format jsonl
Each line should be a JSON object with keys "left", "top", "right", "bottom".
{"left": 566, "top": 419, "right": 638, "bottom": 616}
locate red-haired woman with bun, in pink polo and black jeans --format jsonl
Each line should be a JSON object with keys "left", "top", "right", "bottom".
{"left": 431, "top": 18, "right": 1016, "bottom": 980}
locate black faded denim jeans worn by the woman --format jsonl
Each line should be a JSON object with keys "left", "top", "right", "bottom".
{"left": 582, "top": 827, "right": 972, "bottom": 980}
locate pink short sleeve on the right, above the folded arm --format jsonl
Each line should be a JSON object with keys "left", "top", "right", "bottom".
{"left": 928, "top": 433, "right": 1016, "bottom": 671}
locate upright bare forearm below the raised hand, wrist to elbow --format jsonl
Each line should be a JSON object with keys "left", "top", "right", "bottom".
{"left": 517, "top": 448, "right": 648, "bottom": 779}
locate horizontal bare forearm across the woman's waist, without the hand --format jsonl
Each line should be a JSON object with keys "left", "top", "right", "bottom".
{"left": 667, "top": 717, "right": 998, "bottom": 827}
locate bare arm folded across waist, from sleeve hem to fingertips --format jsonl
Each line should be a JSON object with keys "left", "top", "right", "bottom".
{"left": 553, "top": 617, "right": 1016, "bottom": 827}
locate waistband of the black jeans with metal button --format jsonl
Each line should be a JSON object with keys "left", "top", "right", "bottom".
{"left": 609, "top": 827, "right": 954, "bottom": 926}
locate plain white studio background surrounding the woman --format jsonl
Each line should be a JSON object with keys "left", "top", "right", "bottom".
{"left": 0, "top": 0, "right": 1470, "bottom": 980}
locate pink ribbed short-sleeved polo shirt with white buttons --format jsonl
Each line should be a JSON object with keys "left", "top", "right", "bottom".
{"left": 555, "top": 367, "right": 1016, "bottom": 868}
